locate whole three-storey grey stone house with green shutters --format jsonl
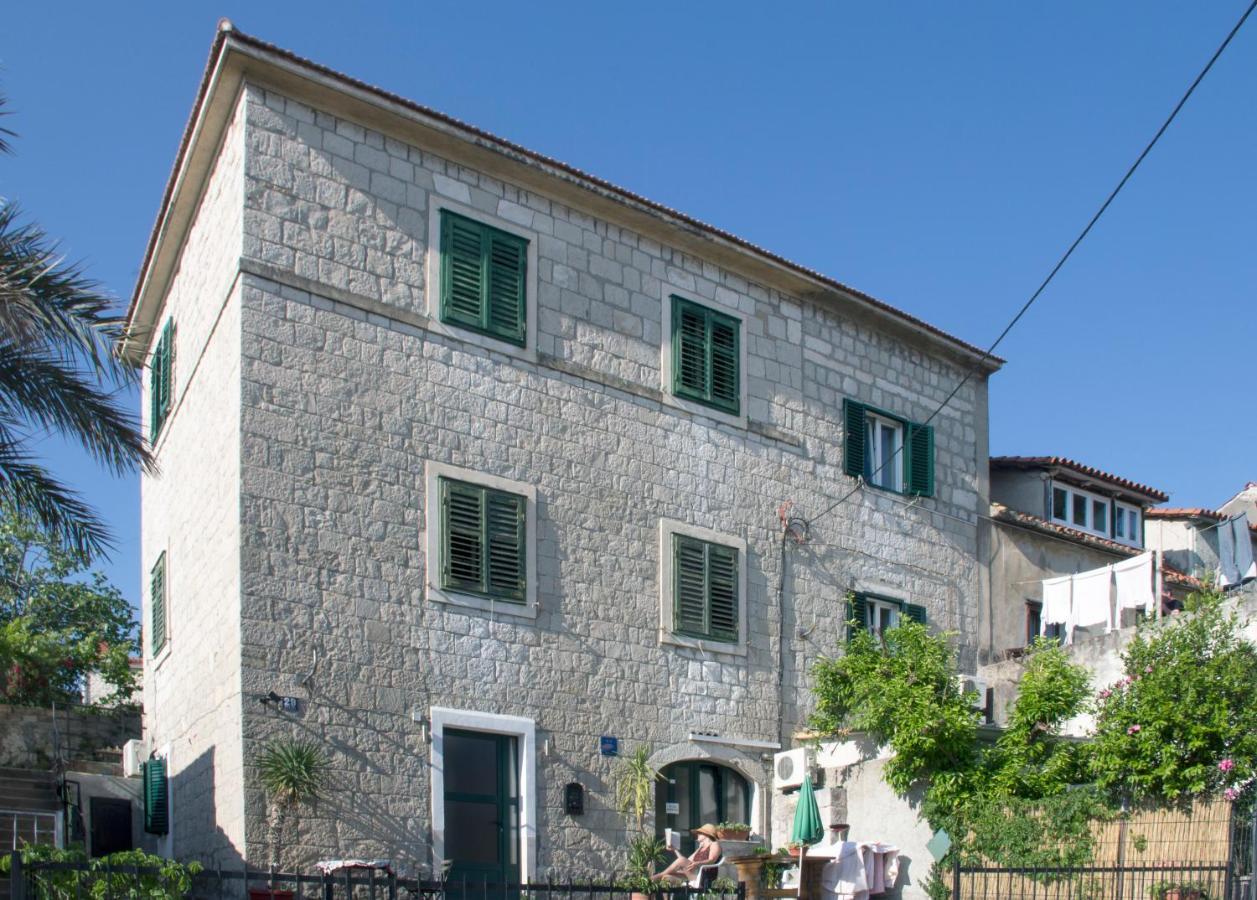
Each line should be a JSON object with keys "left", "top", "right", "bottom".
{"left": 124, "top": 26, "right": 999, "bottom": 877}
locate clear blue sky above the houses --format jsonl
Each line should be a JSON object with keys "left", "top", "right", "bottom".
{"left": 0, "top": 0, "right": 1257, "bottom": 600}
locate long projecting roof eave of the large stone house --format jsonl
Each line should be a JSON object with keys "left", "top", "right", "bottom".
{"left": 123, "top": 21, "right": 1004, "bottom": 376}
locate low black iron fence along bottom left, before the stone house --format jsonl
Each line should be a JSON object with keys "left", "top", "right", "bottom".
{"left": 0, "top": 852, "right": 747, "bottom": 900}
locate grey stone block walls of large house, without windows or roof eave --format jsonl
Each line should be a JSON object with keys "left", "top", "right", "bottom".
{"left": 127, "top": 31, "right": 987, "bottom": 876}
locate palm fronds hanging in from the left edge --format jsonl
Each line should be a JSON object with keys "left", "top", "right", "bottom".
{"left": 0, "top": 96, "right": 152, "bottom": 559}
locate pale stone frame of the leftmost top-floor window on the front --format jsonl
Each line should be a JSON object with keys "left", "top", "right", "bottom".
{"left": 424, "top": 198, "right": 539, "bottom": 362}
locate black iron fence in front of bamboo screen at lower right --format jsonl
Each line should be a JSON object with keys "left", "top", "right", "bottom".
{"left": 952, "top": 862, "right": 1241, "bottom": 900}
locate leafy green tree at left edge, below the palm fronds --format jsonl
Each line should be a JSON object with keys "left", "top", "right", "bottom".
{"left": 0, "top": 509, "right": 140, "bottom": 705}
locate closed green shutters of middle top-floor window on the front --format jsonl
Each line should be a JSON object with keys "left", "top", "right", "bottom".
{"left": 671, "top": 294, "right": 742, "bottom": 415}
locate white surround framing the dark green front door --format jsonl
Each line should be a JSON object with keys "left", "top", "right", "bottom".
{"left": 429, "top": 706, "right": 537, "bottom": 884}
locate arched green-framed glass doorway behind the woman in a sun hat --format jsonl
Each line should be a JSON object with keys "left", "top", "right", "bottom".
{"left": 655, "top": 759, "right": 750, "bottom": 855}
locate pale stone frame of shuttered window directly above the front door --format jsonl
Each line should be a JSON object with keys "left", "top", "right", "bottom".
{"left": 420, "top": 460, "right": 537, "bottom": 618}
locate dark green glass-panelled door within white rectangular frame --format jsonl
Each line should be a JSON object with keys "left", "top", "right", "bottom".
{"left": 441, "top": 728, "right": 519, "bottom": 896}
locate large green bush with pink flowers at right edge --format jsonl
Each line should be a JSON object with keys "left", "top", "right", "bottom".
{"left": 1090, "top": 591, "right": 1257, "bottom": 803}
